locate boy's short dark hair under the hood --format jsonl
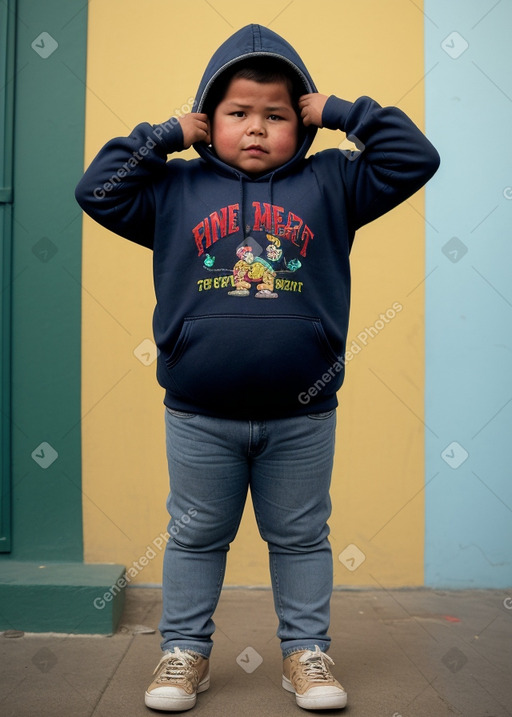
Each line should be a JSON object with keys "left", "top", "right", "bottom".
{"left": 203, "top": 57, "right": 307, "bottom": 119}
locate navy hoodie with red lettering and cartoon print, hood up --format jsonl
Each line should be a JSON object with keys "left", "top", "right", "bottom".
{"left": 76, "top": 25, "right": 439, "bottom": 419}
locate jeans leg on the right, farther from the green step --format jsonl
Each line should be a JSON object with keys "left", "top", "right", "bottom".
{"left": 251, "top": 411, "right": 336, "bottom": 657}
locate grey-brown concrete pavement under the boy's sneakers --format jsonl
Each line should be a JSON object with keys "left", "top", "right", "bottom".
{"left": 0, "top": 588, "right": 512, "bottom": 717}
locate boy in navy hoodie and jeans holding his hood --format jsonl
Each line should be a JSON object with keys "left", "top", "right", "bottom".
{"left": 76, "top": 25, "right": 439, "bottom": 711}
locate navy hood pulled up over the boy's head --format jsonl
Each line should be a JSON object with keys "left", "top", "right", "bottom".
{"left": 194, "top": 25, "right": 317, "bottom": 173}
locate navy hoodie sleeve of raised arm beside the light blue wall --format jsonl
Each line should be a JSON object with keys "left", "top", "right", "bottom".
{"left": 322, "top": 95, "right": 440, "bottom": 230}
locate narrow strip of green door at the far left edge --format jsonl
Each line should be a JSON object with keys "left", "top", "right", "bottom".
{"left": 0, "top": 0, "right": 15, "bottom": 553}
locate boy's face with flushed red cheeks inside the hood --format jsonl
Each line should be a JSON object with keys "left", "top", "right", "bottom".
{"left": 212, "top": 77, "right": 299, "bottom": 176}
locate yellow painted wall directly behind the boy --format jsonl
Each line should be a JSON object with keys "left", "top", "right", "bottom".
{"left": 82, "top": 0, "right": 424, "bottom": 587}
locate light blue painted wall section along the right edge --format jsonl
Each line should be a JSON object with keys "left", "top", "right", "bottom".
{"left": 424, "top": 0, "right": 512, "bottom": 588}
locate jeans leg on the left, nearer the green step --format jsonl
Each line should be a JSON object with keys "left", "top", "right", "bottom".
{"left": 159, "top": 409, "right": 249, "bottom": 657}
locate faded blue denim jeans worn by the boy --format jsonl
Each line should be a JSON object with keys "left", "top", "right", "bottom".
{"left": 159, "top": 408, "right": 336, "bottom": 657}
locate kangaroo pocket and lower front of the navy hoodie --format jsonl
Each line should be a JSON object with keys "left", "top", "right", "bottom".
{"left": 161, "top": 315, "right": 343, "bottom": 416}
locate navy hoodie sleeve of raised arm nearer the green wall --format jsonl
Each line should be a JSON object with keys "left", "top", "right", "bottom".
{"left": 75, "top": 118, "right": 183, "bottom": 249}
